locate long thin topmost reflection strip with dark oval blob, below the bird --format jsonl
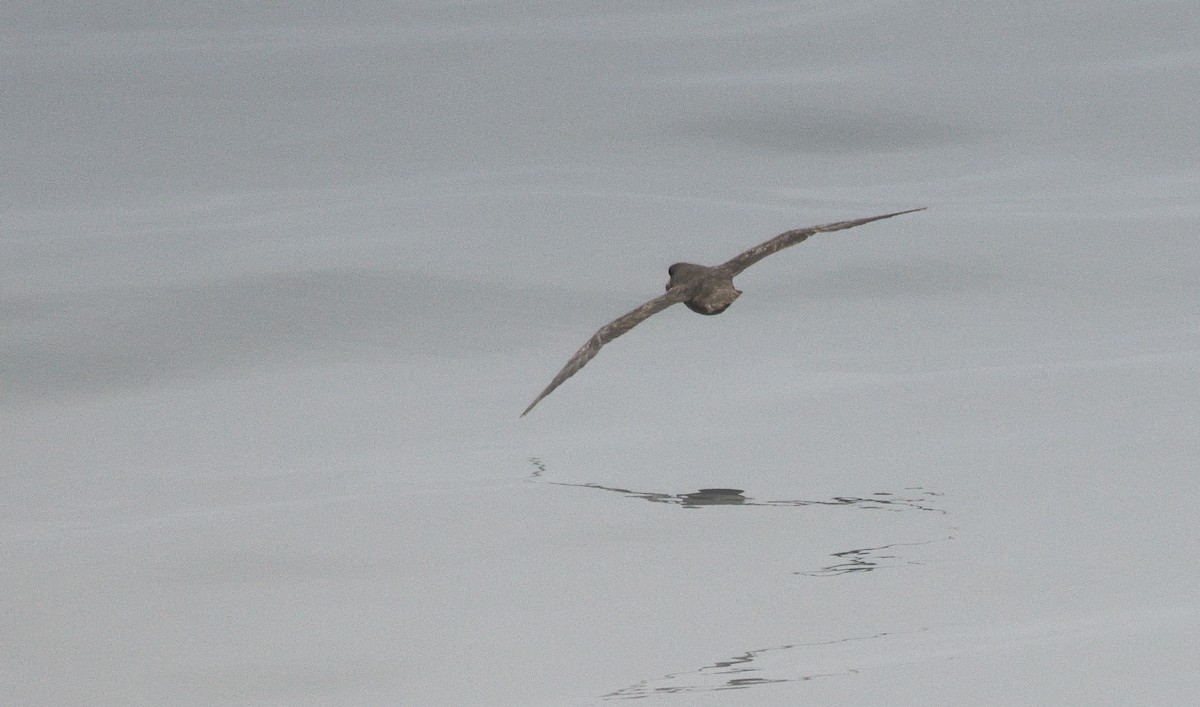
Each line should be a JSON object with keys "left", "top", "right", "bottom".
{"left": 529, "top": 457, "right": 946, "bottom": 514}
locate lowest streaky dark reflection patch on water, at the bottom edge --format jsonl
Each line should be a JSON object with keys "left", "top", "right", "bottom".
{"left": 601, "top": 631, "right": 895, "bottom": 700}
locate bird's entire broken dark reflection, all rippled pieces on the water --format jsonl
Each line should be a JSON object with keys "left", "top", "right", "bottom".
{"left": 527, "top": 457, "right": 956, "bottom": 701}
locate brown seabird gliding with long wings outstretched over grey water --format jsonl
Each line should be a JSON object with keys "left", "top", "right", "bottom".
{"left": 521, "top": 206, "right": 925, "bottom": 418}
